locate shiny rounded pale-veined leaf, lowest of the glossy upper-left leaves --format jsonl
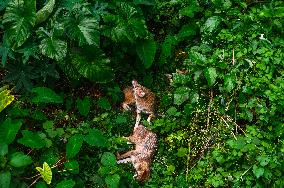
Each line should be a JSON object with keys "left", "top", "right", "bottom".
{"left": 39, "top": 37, "right": 67, "bottom": 61}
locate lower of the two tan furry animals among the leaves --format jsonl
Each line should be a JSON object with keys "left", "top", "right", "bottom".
{"left": 117, "top": 125, "right": 157, "bottom": 182}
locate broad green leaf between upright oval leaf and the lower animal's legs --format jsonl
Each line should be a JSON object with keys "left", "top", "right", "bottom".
{"left": 84, "top": 129, "right": 108, "bottom": 147}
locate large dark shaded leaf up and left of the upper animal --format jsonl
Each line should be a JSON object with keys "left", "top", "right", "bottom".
{"left": 71, "top": 52, "right": 114, "bottom": 83}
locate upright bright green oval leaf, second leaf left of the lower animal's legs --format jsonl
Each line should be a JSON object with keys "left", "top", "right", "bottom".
{"left": 66, "top": 134, "right": 84, "bottom": 159}
